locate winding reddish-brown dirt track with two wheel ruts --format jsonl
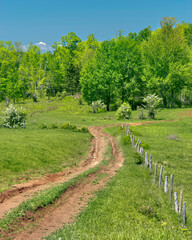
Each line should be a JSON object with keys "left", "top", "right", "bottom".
{"left": 0, "top": 121, "right": 165, "bottom": 240}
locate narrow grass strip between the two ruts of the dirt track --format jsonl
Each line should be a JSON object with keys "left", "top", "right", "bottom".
{"left": 0, "top": 140, "right": 113, "bottom": 237}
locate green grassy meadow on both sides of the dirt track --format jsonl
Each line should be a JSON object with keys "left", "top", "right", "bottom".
{"left": 0, "top": 97, "right": 192, "bottom": 240}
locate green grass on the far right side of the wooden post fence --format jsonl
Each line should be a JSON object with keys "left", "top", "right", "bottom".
{"left": 127, "top": 118, "right": 192, "bottom": 228}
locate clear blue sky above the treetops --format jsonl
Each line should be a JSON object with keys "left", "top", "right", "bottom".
{"left": 0, "top": 0, "right": 192, "bottom": 45}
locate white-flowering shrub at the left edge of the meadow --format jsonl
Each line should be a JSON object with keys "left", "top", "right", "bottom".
{"left": 2, "top": 104, "right": 27, "bottom": 128}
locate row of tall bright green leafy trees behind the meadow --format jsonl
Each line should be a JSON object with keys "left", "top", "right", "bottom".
{"left": 0, "top": 17, "right": 192, "bottom": 110}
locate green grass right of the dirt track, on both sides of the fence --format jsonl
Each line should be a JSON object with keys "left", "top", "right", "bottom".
{"left": 48, "top": 123, "right": 192, "bottom": 240}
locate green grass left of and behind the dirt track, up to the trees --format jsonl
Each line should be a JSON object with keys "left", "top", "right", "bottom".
{"left": 0, "top": 96, "right": 190, "bottom": 192}
